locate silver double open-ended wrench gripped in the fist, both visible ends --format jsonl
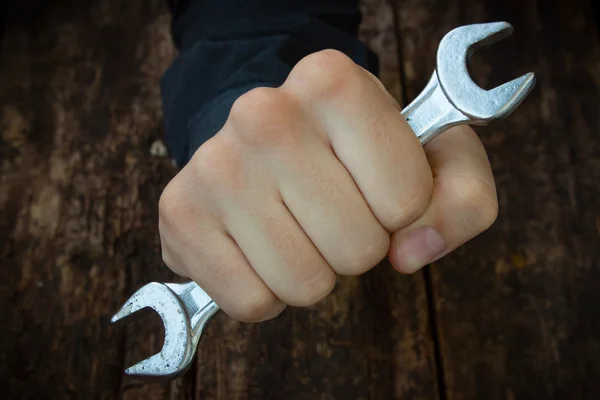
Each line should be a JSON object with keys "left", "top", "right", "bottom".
{"left": 112, "top": 22, "right": 535, "bottom": 379}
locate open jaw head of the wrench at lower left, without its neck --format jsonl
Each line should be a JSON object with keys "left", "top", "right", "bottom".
{"left": 111, "top": 282, "right": 194, "bottom": 379}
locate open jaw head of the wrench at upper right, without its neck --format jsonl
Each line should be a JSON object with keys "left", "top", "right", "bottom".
{"left": 436, "top": 22, "right": 535, "bottom": 123}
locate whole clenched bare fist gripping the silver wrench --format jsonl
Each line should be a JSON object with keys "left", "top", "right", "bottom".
{"left": 159, "top": 50, "right": 498, "bottom": 322}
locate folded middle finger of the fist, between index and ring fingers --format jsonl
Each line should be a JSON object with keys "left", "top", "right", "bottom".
{"left": 276, "top": 123, "right": 389, "bottom": 275}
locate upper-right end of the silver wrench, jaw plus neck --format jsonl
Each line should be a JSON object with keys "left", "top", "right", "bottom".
{"left": 402, "top": 22, "right": 535, "bottom": 144}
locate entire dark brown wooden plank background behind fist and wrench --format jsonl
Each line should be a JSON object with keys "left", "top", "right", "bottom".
{"left": 0, "top": 0, "right": 600, "bottom": 400}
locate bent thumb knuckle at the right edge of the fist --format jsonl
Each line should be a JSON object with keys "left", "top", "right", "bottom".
{"left": 455, "top": 179, "right": 498, "bottom": 232}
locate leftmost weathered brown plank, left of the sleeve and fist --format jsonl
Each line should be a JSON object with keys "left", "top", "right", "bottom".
{"left": 0, "top": 0, "right": 185, "bottom": 399}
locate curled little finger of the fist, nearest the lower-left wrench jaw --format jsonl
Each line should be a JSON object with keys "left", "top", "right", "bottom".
{"left": 159, "top": 168, "right": 285, "bottom": 322}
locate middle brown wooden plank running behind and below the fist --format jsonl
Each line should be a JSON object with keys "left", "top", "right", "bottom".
{"left": 196, "top": 0, "right": 437, "bottom": 400}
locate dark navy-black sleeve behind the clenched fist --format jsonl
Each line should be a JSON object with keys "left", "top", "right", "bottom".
{"left": 161, "top": 0, "right": 378, "bottom": 167}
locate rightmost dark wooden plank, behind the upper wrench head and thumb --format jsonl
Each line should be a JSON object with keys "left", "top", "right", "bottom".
{"left": 399, "top": 0, "right": 600, "bottom": 399}
